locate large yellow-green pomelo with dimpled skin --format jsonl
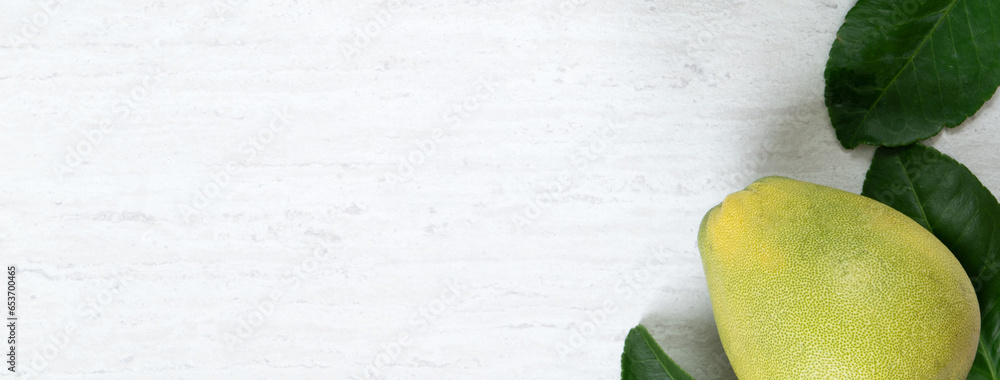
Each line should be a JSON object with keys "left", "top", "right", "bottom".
{"left": 698, "top": 177, "right": 980, "bottom": 380}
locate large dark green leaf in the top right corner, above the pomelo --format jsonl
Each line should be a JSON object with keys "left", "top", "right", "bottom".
{"left": 824, "top": 0, "right": 1000, "bottom": 149}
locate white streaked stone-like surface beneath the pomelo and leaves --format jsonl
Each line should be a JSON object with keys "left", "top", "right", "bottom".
{"left": 0, "top": 0, "right": 1000, "bottom": 380}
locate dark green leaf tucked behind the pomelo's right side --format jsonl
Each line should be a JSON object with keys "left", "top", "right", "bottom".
{"left": 861, "top": 144, "right": 1000, "bottom": 380}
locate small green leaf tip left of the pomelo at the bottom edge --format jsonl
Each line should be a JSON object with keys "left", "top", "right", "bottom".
{"left": 622, "top": 325, "right": 694, "bottom": 380}
